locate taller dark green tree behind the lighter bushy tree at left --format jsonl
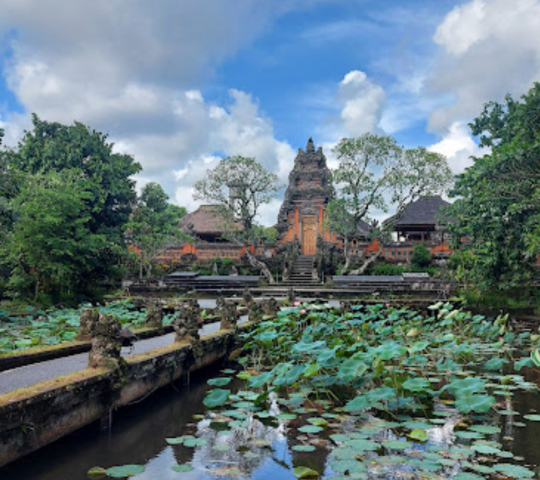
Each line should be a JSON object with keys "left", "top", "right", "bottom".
{"left": 2, "top": 115, "right": 141, "bottom": 295}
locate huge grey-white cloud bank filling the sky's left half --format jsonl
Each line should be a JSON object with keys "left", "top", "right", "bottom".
{"left": 0, "top": 0, "right": 320, "bottom": 223}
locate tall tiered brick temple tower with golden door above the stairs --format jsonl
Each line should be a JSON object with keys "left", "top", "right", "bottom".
{"left": 276, "top": 138, "right": 336, "bottom": 255}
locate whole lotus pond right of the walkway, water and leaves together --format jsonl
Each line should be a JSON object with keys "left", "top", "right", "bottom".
{"left": 5, "top": 304, "right": 540, "bottom": 480}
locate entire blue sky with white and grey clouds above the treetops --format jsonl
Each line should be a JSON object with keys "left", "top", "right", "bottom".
{"left": 0, "top": 0, "right": 540, "bottom": 225}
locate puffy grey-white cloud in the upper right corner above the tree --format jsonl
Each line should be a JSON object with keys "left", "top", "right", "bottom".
{"left": 426, "top": 0, "right": 540, "bottom": 133}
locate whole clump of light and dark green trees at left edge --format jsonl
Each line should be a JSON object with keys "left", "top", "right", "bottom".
{"left": 0, "top": 115, "right": 141, "bottom": 301}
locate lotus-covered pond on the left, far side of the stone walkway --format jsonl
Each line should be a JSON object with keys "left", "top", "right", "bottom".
{"left": 0, "top": 300, "right": 173, "bottom": 355}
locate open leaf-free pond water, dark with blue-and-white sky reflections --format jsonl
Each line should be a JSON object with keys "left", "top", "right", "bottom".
{"left": 0, "top": 370, "right": 540, "bottom": 480}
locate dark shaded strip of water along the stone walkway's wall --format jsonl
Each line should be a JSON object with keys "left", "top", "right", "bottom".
{"left": 0, "top": 369, "right": 216, "bottom": 480}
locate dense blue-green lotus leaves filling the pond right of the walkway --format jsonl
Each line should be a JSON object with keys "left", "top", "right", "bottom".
{"left": 181, "top": 302, "right": 540, "bottom": 479}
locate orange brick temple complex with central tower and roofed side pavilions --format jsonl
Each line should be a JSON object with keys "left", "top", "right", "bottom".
{"left": 159, "top": 138, "right": 451, "bottom": 264}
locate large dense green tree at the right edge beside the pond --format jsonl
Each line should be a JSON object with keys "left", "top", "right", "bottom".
{"left": 449, "top": 83, "right": 540, "bottom": 290}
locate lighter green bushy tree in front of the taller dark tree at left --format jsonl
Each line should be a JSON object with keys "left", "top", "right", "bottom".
{"left": 7, "top": 171, "right": 98, "bottom": 301}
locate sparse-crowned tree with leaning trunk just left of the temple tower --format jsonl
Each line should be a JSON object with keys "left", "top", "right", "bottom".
{"left": 194, "top": 156, "right": 279, "bottom": 283}
